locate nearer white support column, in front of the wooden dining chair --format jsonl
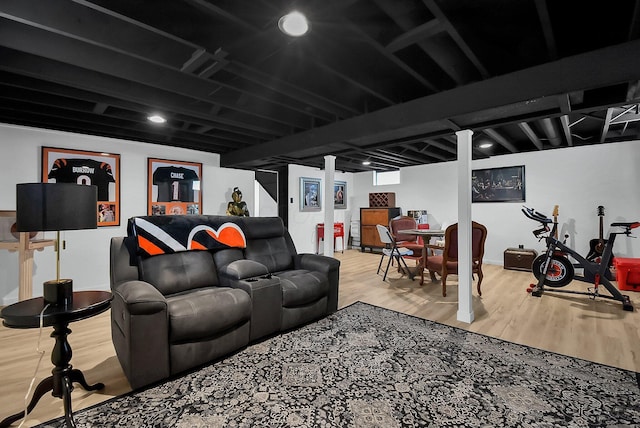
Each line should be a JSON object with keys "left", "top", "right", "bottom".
{"left": 456, "top": 129, "right": 473, "bottom": 324}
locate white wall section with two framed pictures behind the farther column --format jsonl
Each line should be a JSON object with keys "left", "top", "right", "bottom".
{"left": 287, "top": 165, "right": 361, "bottom": 253}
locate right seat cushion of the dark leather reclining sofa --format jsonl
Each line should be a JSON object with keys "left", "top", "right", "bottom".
{"left": 276, "top": 269, "right": 329, "bottom": 307}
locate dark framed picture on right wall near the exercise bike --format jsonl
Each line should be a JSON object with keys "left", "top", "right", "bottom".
{"left": 471, "top": 165, "right": 526, "bottom": 202}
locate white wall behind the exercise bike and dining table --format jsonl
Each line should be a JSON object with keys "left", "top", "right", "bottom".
{"left": 352, "top": 141, "right": 640, "bottom": 264}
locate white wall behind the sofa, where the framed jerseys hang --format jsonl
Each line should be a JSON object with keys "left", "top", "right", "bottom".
{"left": 0, "top": 124, "right": 255, "bottom": 304}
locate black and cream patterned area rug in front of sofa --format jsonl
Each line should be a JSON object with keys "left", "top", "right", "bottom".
{"left": 42, "top": 303, "right": 640, "bottom": 428}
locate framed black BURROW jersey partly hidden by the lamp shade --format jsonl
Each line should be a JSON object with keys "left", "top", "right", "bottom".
{"left": 42, "top": 147, "right": 120, "bottom": 227}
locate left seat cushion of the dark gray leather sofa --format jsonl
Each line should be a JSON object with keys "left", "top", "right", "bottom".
{"left": 167, "top": 287, "right": 251, "bottom": 343}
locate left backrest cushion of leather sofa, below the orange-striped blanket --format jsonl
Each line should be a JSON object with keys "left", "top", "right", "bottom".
{"left": 140, "top": 251, "right": 218, "bottom": 296}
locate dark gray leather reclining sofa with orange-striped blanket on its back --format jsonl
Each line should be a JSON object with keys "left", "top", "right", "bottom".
{"left": 110, "top": 216, "right": 340, "bottom": 389}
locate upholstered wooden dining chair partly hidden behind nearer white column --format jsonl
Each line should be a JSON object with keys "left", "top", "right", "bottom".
{"left": 426, "top": 221, "right": 487, "bottom": 297}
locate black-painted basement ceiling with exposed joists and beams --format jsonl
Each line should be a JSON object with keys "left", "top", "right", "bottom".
{"left": 0, "top": 0, "right": 640, "bottom": 172}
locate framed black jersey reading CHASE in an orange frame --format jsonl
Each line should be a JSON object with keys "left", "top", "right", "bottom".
{"left": 147, "top": 158, "right": 202, "bottom": 215}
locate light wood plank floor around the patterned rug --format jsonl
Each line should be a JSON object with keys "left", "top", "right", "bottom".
{"left": 0, "top": 250, "right": 640, "bottom": 426}
